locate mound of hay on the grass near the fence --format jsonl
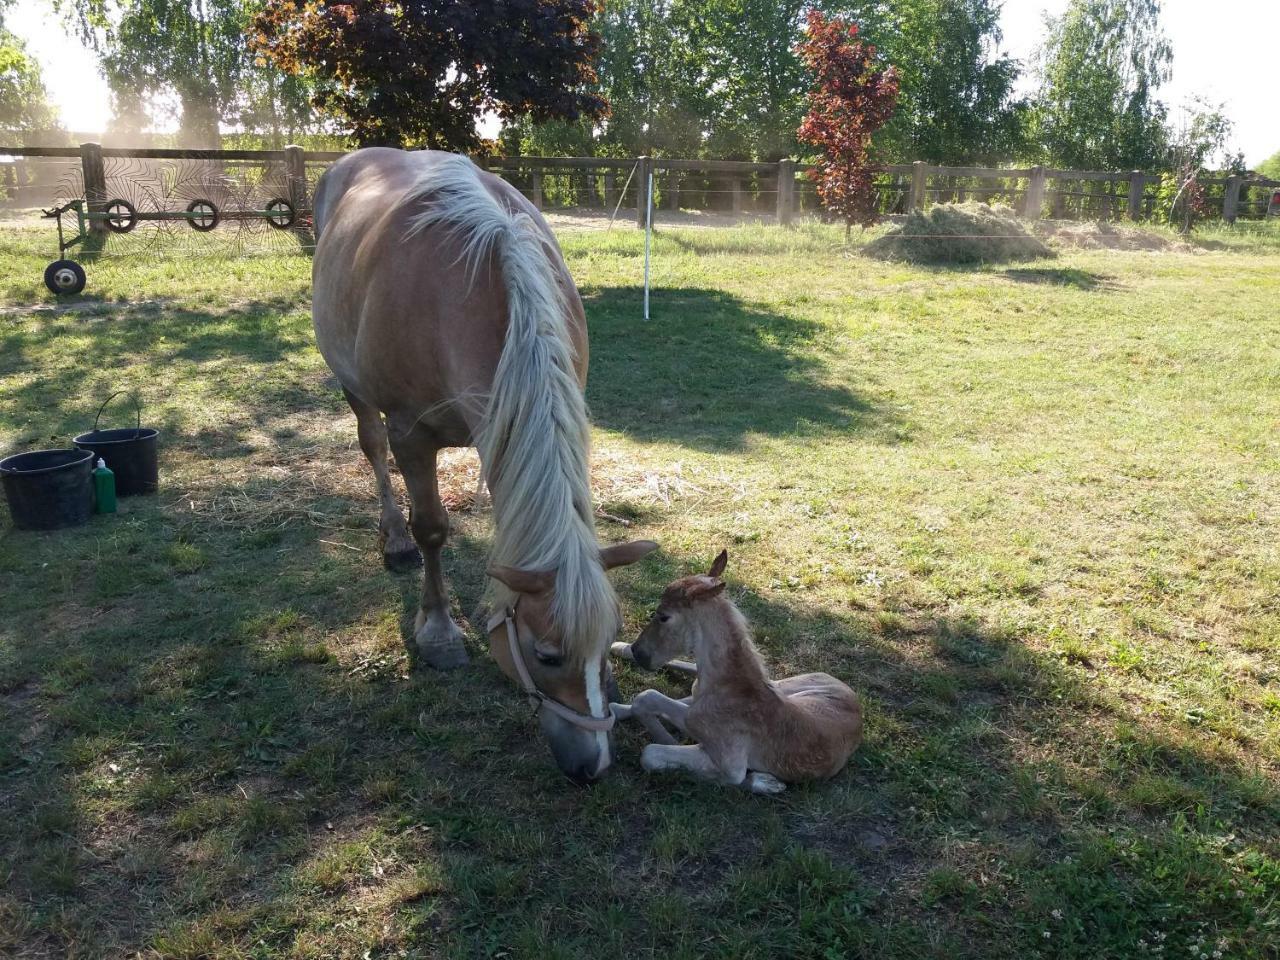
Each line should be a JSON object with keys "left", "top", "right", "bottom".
{"left": 865, "top": 204, "right": 1053, "bottom": 264}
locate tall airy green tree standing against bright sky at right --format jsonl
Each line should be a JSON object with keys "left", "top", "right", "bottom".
{"left": 1033, "top": 0, "right": 1172, "bottom": 170}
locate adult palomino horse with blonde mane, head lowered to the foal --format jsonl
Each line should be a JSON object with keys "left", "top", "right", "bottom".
{"left": 312, "top": 148, "right": 655, "bottom": 781}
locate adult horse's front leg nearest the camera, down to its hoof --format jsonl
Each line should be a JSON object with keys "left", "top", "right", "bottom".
{"left": 392, "top": 434, "right": 468, "bottom": 669}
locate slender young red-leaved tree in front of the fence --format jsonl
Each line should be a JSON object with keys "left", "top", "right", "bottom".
{"left": 796, "top": 10, "right": 897, "bottom": 237}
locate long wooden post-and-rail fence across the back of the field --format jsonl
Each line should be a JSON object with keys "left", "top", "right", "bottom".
{"left": 0, "top": 143, "right": 1280, "bottom": 224}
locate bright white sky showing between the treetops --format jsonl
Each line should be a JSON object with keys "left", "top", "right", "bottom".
{"left": 6, "top": 0, "right": 1280, "bottom": 166}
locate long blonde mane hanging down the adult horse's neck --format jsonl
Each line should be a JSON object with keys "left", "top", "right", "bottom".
{"left": 410, "top": 156, "right": 621, "bottom": 663}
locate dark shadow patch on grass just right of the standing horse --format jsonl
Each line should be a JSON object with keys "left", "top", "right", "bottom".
{"left": 582, "top": 287, "right": 908, "bottom": 451}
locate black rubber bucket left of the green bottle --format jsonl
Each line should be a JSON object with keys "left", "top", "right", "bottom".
{"left": 0, "top": 449, "right": 93, "bottom": 530}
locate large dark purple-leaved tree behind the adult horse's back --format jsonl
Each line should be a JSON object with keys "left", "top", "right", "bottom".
{"left": 253, "top": 0, "right": 605, "bottom": 150}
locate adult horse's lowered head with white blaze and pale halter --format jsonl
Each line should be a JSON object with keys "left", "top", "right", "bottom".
{"left": 489, "top": 540, "right": 658, "bottom": 783}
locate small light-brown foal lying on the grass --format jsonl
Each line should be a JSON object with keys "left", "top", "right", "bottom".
{"left": 612, "top": 552, "right": 863, "bottom": 794}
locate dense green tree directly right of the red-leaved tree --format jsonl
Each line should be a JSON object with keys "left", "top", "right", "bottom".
{"left": 838, "top": 0, "right": 1027, "bottom": 165}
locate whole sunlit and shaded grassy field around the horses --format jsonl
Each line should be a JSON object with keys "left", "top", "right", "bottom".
{"left": 0, "top": 217, "right": 1280, "bottom": 960}
